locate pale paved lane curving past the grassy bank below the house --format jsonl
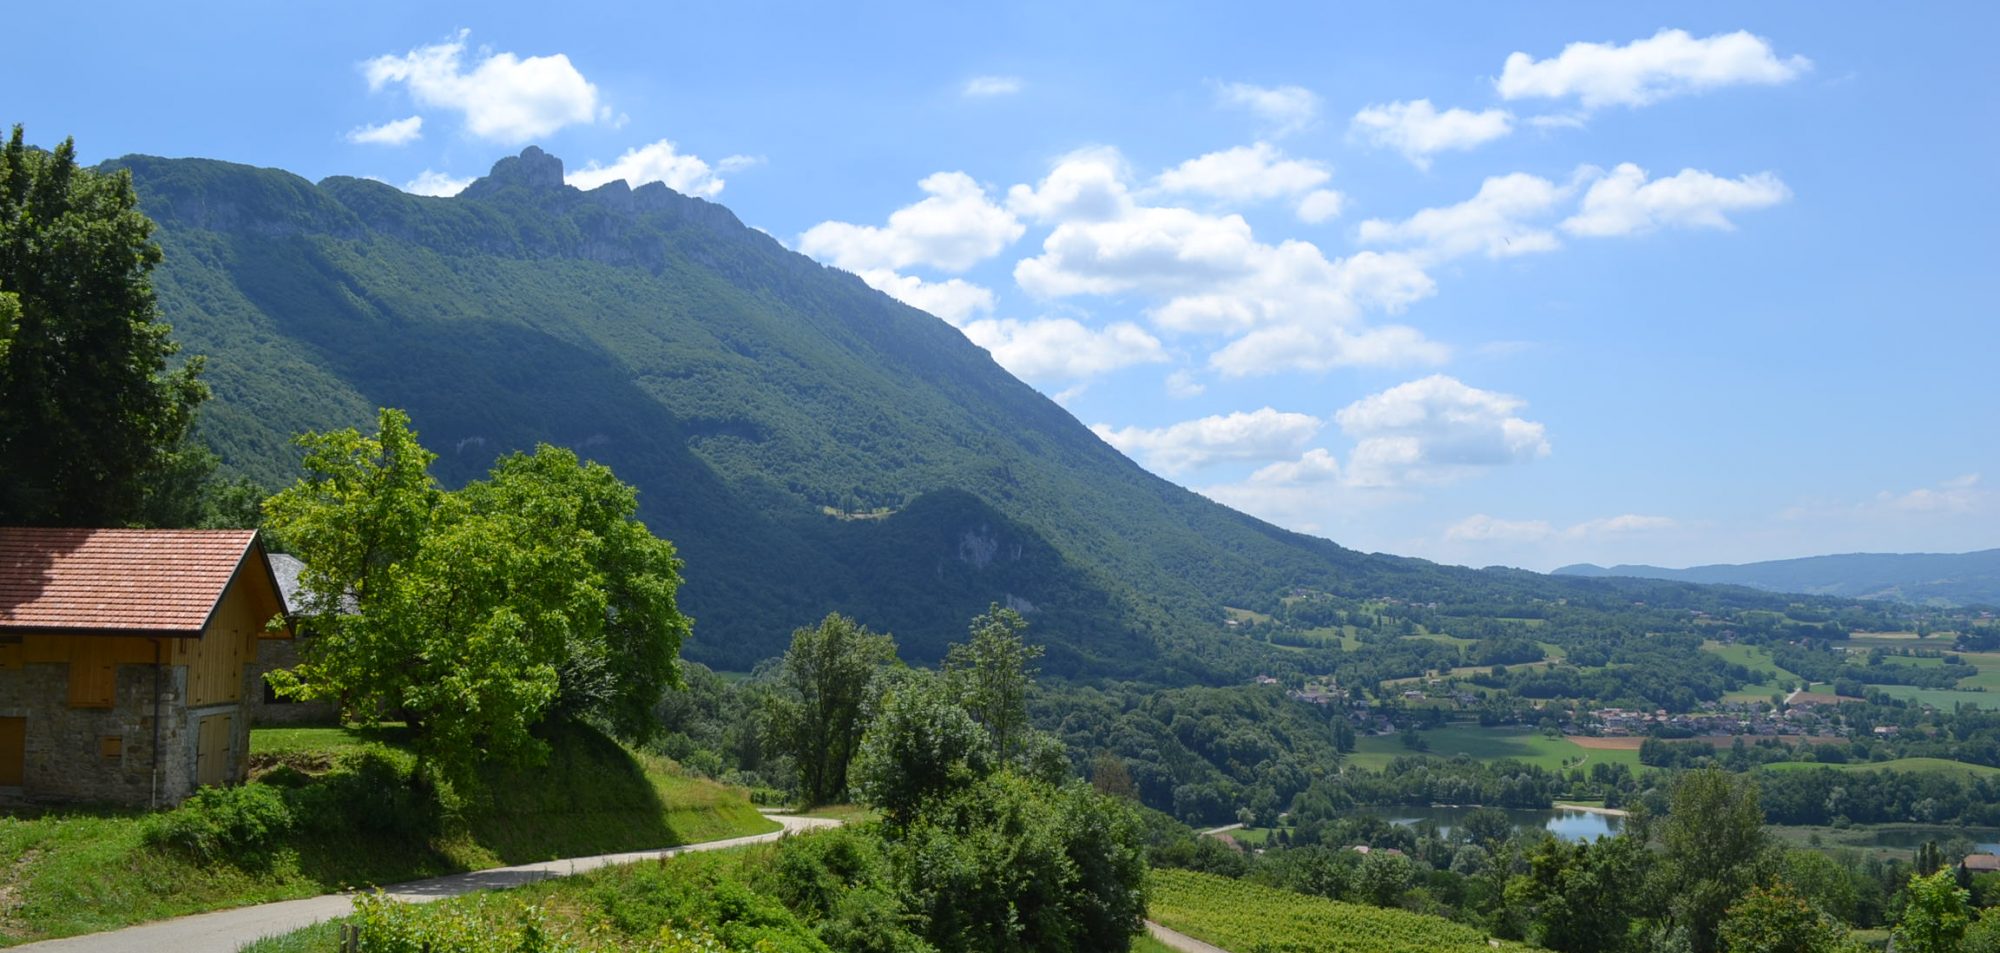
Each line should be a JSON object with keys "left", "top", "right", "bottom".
{"left": 14, "top": 815, "right": 840, "bottom": 953}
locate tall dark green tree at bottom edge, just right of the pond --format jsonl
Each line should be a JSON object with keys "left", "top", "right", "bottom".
{"left": 1658, "top": 767, "right": 1770, "bottom": 953}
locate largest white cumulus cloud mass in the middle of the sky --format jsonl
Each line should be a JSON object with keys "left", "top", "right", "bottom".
{"left": 1008, "top": 148, "right": 1444, "bottom": 374}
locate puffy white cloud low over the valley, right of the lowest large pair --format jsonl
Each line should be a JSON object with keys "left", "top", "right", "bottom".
{"left": 1334, "top": 374, "right": 1550, "bottom": 487}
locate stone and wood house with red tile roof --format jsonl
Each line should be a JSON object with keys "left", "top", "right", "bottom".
{"left": 0, "top": 527, "right": 290, "bottom": 807}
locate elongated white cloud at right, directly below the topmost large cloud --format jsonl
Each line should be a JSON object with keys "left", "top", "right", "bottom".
{"left": 1562, "top": 162, "right": 1792, "bottom": 236}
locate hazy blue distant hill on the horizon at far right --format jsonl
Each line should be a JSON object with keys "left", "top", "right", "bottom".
{"left": 1554, "top": 549, "right": 2000, "bottom": 607}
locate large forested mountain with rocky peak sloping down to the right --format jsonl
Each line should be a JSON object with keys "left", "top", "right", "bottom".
{"left": 108, "top": 146, "right": 1784, "bottom": 675}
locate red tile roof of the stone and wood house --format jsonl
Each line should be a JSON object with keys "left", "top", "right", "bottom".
{"left": 0, "top": 527, "right": 268, "bottom": 637}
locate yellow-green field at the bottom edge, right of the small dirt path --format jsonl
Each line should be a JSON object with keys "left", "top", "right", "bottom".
{"left": 1148, "top": 869, "right": 1530, "bottom": 953}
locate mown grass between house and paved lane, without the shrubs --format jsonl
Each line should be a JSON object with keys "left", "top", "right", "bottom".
{"left": 0, "top": 729, "right": 776, "bottom": 947}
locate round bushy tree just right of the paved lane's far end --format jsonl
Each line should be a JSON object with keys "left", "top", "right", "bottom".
{"left": 850, "top": 673, "right": 994, "bottom": 825}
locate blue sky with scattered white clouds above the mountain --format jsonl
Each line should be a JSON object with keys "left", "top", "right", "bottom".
{"left": 11, "top": 2, "right": 2000, "bottom": 569}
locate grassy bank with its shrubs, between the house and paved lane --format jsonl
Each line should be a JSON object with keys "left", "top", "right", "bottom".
{"left": 0, "top": 729, "right": 776, "bottom": 947}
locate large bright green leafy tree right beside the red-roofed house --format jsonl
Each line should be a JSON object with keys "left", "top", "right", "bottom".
{"left": 266, "top": 410, "right": 688, "bottom": 777}
